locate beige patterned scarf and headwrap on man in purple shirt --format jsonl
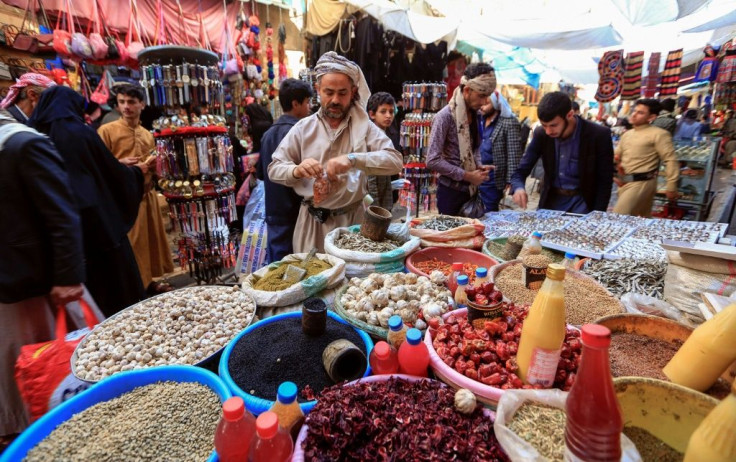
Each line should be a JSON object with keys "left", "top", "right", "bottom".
{"left": 449, "top": 73, "right": 496, "bottom": 197}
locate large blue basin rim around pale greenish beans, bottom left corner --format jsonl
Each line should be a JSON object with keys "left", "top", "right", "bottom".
{"left": 0, "top": 366, "right": 232, "bottom": 462}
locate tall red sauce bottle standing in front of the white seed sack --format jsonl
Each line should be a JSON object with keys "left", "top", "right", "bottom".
{"left": 565, "top": 324, "right": 624, "bottom": 462}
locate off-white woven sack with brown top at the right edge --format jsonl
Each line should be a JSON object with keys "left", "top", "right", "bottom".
{"left": 664, "top": 252, "right": 736, "bottom": 324}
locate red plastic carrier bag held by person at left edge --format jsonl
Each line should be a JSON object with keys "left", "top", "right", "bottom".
{"left": 15, "top": 299, "right": 99, "bottom": 420}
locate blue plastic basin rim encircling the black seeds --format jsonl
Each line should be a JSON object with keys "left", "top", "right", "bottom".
{"left": 219, "top": 311, "right": 373, "bottom": 416}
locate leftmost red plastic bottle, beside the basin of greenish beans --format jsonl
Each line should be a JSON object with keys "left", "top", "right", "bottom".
{"left": 215, "top": 396, "right": 256, "bottom": 462}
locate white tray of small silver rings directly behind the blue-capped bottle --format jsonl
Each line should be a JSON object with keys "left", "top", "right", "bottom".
{"left": 542, "top": 220, "right": 631, "bottom": 253}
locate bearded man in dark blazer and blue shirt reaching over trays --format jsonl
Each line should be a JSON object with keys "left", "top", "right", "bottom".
{"left": 511, "top": 91, "right": 613, "bottom": 213}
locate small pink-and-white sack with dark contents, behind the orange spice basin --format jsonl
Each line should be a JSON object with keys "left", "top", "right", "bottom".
{"left": 409, "top": 215, "right": 486, "bottom": 248}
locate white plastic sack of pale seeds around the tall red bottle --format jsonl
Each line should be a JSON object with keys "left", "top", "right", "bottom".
{"left": 493, "top": 389, "right": 641, "bottom": 462}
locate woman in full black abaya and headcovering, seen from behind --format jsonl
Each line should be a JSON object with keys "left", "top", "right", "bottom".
{"left": 29, "top": 86, "right": 144, "bottom": 316}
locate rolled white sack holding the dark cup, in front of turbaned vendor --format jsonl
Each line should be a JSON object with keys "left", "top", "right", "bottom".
{"left": 325, "top": 226, "right": 420, "bottom": 278}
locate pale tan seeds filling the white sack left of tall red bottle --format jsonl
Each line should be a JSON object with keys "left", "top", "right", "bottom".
{"left": 508, "top": 403, "right": 566, "bottom": 461}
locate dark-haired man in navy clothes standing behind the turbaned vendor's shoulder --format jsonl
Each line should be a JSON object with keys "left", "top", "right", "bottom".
{"left": 257, "top": 79, "right": 312, "bottom": 262}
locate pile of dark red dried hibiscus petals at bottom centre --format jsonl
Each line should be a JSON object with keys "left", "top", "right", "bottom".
{"left": 302, "top": 378, "right": 508, "bottom": 462}
